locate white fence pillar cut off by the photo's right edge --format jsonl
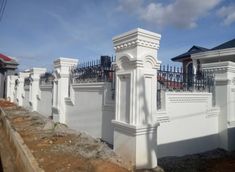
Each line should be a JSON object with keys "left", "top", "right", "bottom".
{"left": 202, "top": 61, "right": 235, "bottom": 151}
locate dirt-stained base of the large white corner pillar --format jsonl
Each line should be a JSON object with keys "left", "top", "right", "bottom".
{"left": 112, "top": 120, "right": 159, "bottom": 169}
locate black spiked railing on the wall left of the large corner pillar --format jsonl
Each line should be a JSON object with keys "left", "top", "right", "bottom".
{"left": 71, "top": 56, "right": 114, "bottom": 83}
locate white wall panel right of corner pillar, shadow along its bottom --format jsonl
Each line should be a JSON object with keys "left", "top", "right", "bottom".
{"left": 154, "top": 92, "right": 219, "bottom": 158}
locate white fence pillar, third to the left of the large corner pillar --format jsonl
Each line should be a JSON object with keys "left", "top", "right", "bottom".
{"left": 14, "top": 72, "right": 30, "bottom": 106}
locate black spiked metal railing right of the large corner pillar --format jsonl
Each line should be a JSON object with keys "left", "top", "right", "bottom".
{"left": 157, "top": 65, "right": 215, "bottom": 109}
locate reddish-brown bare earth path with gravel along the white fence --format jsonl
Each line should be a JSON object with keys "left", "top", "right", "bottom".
{"left": 0, "top": 103, "right": 129, "bottom": 172}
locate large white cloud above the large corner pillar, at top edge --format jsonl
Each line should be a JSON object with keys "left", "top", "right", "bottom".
{"left": 118, "top": 0, "right": 221, "bottom": 28}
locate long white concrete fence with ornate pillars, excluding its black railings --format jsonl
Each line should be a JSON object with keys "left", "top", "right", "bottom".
{"left": 7, "top": 29, "right": 235, "bottom": 169}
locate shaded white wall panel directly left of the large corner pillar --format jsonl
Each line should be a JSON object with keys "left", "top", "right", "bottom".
{"left": 66, "top": 82, "right": 114, "bottom": 144}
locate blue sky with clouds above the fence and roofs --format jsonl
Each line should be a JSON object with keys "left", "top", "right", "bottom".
{"left": 0, "top": 0, "right": 235, "bottom": 70}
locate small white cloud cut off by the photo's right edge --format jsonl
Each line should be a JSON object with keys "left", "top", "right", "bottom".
{"left": 217, "top": 4, "right": 235, "bottom": 25}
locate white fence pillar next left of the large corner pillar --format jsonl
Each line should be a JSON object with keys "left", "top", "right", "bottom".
{"left": 52, "top": 58, "right": 78, "bottom": 123}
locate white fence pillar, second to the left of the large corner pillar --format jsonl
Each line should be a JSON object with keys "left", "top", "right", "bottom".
{"left": 29, "top": 68, "right": 46, "bottom": 111}
